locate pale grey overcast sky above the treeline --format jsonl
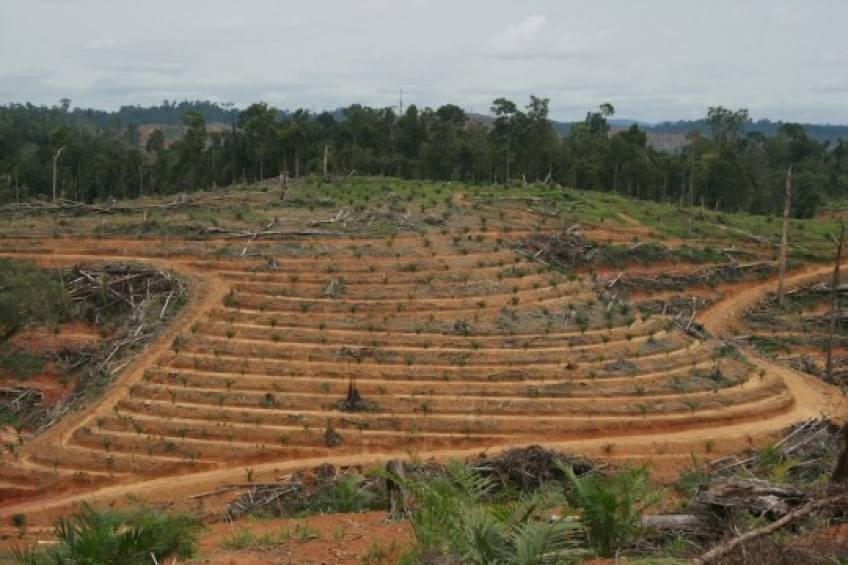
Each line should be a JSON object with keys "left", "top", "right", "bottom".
{"left": 0, "top": 0, "right": 848, "bottom": 124}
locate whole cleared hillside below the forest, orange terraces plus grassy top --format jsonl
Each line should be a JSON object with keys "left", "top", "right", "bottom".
{"left": 0, "top": 180, "right": 848, "bottom": 535}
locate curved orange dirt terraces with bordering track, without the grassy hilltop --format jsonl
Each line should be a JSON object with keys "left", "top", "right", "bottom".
{"left": 0, "top": 227, "right": 848, "bottom": 533}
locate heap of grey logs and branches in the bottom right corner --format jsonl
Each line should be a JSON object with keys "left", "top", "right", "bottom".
{"left": 642, "top": 419, "right": 848, "bottom": 564}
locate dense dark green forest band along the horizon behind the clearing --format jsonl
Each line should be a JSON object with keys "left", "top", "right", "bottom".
{"left": 0, "top": 96, "right": 848, "bottom": 217}
